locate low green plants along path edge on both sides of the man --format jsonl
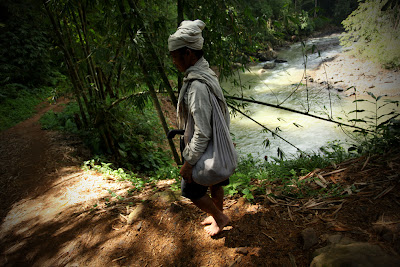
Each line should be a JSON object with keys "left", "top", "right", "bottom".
{"left": 79, "top": 142, "right": 354, "bottom": 200}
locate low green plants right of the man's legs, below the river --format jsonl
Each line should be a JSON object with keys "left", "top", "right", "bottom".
{"left": 225, "top": 142, "right": 355, "bottom": 200}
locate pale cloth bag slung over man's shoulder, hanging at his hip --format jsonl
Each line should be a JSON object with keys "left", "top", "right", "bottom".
{"left": 184, "top": 90, "right": 238, "bottom": 186}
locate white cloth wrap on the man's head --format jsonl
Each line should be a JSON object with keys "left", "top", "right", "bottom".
{"left": 168, "top": 19, "right": 206, "bottom": 51}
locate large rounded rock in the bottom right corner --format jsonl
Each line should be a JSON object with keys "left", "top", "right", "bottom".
{"left": 310, "top": 238, "right": 400, "bottom": 267}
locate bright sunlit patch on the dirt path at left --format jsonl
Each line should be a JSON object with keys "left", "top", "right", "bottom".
{"left": 0, "top": 169, "right": 132, "bottom": 238}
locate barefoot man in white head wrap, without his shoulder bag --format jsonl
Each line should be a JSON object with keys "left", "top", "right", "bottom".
{"left": 168, "top": 20, "right": 230, "bottom": 236}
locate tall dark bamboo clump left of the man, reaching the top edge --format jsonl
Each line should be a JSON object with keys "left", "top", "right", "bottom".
{"left": 44, "top": 0, "right": 179, "bottom": 171}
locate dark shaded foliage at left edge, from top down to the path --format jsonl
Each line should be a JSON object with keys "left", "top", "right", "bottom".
{"left": 0, "top": 0, "right": 58, "bottom": 131}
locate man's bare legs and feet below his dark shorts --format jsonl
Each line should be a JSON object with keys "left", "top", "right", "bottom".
{"left": 193, "top": 191, "right": 229, "bottom": 236}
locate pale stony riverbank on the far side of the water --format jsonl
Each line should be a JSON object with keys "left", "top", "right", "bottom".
{"left": 308, "top": 43, "right": 400, "bottom": 96}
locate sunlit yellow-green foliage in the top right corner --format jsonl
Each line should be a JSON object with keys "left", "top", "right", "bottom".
{"left": 341, "top": 0, "right": 400, "bottom": 68}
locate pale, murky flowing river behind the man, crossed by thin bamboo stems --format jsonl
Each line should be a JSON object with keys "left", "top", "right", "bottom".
{"left": 221, "top": 35, "right": 398, "bottom": 159}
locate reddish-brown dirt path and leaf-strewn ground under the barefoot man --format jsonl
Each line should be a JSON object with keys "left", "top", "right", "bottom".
{"left": 0, "top": 99, "right": 400, "bottom": 266}
